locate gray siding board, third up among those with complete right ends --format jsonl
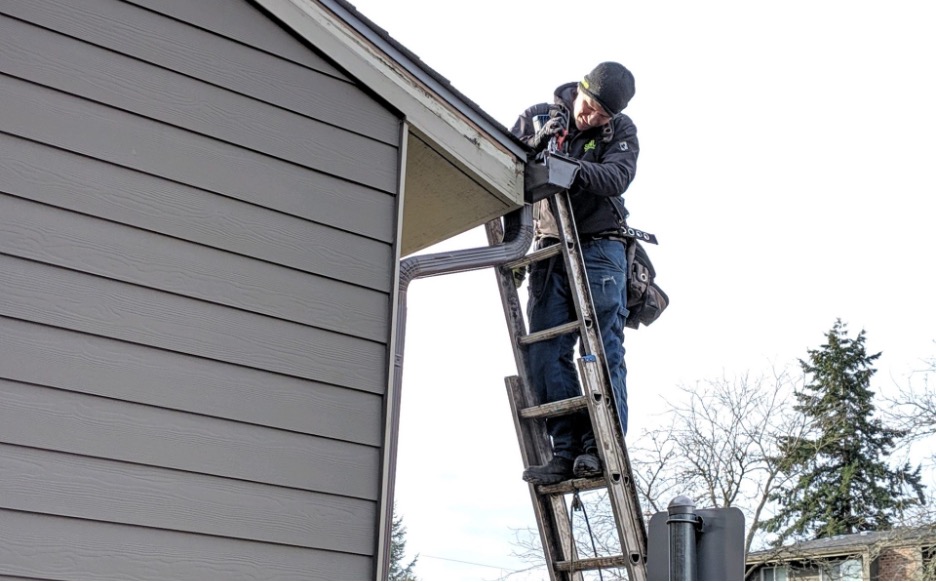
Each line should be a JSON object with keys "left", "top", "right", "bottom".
{"left": 0, "top": 316, "right": 383, "bottom": 448}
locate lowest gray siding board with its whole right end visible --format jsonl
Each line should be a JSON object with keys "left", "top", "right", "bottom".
{"left": 0, "top": 445, "right": 376, "bottom": 555}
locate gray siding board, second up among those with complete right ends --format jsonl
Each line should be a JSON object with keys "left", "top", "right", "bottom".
{"left": 0, "top": 380, "right": 380, "bottom": 502}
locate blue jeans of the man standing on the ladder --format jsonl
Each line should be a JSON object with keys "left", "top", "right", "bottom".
{"left": 527, "top": 240, "right": 627, "bottom": 459}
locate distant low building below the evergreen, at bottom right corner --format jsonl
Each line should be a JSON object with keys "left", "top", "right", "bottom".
{"left": 747, "top": 526, "right": 936, "bottom": 580}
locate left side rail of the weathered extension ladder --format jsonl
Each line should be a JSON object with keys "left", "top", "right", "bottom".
{"left": 485, "top": 220, "right": 582, "bottom": 580}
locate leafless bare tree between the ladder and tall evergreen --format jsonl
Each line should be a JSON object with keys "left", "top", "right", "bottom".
{"left": 632, "top": 370, "right": 807, "bottom": 552}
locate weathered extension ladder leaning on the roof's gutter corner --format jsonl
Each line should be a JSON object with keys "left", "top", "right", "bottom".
{"left": 486, "top": 190, "right": 647, "bottom": 580}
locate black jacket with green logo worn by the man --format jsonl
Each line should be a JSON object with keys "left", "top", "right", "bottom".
{"left": 511, "top": 83, "right": 640, "bottom": 238}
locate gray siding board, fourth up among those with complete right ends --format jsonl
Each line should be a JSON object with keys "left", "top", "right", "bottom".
{"left": 0, "top": 255, "right": 387, "bottom": 393}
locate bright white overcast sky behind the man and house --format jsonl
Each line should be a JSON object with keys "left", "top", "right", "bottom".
{"left": 352, "top": 0, "right": 936, "bottom": 580}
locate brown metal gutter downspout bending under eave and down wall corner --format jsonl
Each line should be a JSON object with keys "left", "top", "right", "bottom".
{"left": 377, "top": 204, "right": 533, "bottom": 580}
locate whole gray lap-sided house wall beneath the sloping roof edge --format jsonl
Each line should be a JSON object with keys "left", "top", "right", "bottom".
{"left": 0, "top": 0, "right": 400, "bottom": 579}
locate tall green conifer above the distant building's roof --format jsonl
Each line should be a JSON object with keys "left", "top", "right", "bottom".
{"left": 766, "top": 319, "right": 924, "bottom": 542}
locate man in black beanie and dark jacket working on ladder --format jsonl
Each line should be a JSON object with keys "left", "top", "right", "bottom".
{"left": 512, "top": 62, "right": 639, "bottom": 485}
